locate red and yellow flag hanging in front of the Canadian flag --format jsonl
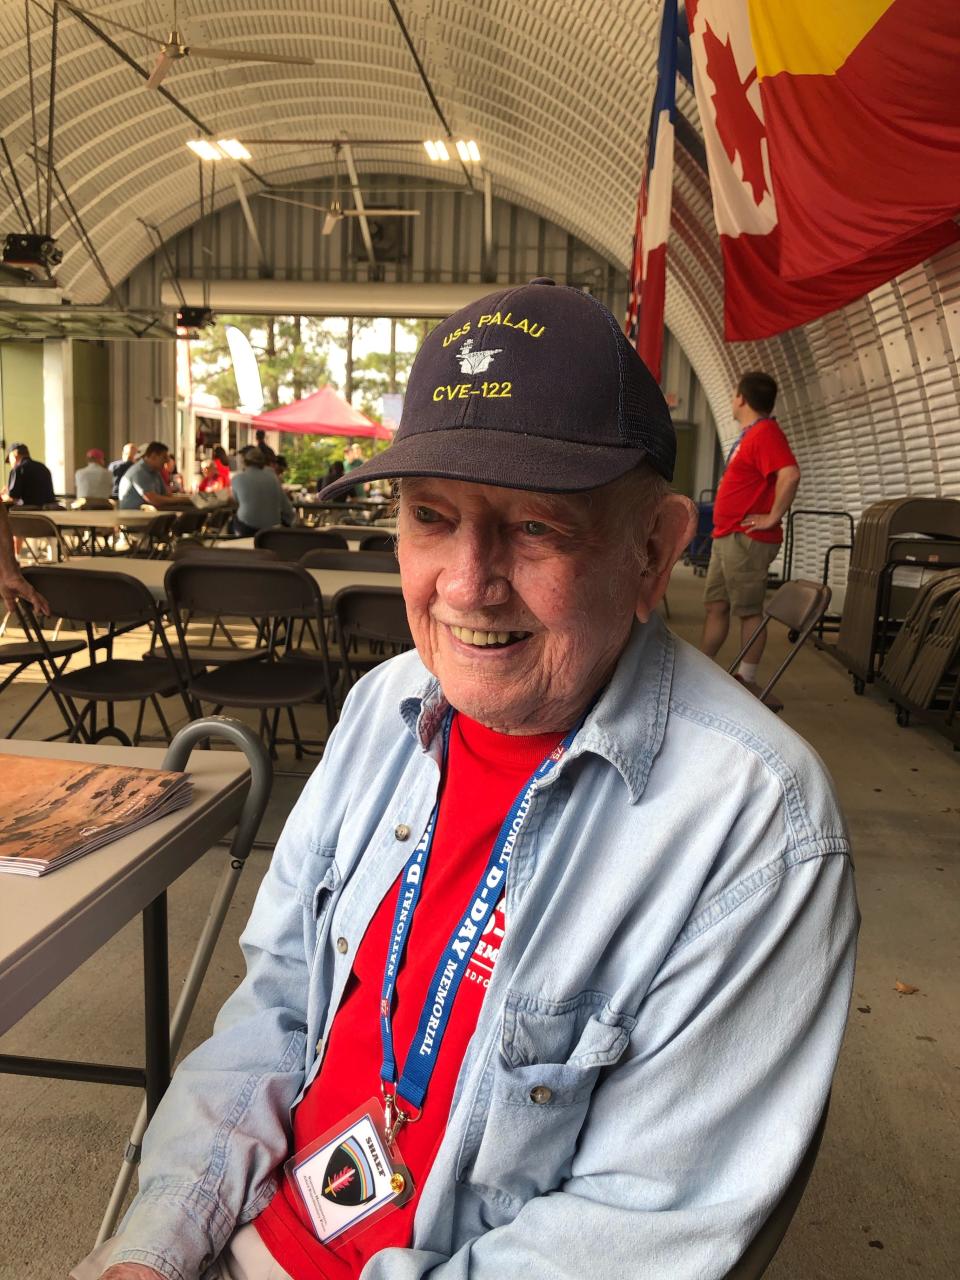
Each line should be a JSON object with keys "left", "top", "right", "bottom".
{"left": 749, "top": 0, "right": 960, "bottom": 280}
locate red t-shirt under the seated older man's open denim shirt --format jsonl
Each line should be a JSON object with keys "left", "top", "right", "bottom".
{"left": 255, "top": 716, "right": 563, "bottom": 1280}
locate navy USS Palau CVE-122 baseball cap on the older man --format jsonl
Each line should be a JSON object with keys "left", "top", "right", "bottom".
{"left": 320, "top": 279, "right": 677, "bottom": 499}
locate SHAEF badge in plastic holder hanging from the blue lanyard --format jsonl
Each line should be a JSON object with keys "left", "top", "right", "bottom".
{"left": 289, "top": 1098, "right": 413, "bottom": 1244}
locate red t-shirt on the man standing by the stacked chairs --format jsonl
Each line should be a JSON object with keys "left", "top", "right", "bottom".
{"left": 713, "top": 417, "right": 796, "bottom": 543}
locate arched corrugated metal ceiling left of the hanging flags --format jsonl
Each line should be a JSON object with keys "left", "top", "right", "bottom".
{"left": 0, "top": 0, "right": 695, "bottom": 302}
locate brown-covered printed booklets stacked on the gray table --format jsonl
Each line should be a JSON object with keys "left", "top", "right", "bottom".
{"left": 0, "top": 755, "right": 193, "bottom": 876}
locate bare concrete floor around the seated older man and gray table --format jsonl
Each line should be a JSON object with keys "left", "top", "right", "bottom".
{"left": 0, "top": 568, "right": 960, "bottom": 1280}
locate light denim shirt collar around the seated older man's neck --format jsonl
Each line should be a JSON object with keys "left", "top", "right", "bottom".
{"left": 399, "top": 614, "right": 675, "bottom": 804}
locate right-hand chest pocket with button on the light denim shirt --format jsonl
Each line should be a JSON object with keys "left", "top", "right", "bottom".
{"left": 457, "top": 991, "right": 635, "bottom": 1208}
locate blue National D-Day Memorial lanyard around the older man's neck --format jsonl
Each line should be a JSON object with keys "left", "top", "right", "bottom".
{"left": 380, "top": 712, "right": 582, "bottom": 1107}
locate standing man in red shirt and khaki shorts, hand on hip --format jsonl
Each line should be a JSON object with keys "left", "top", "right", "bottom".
{"left": 700, "top": 372, "right": 800, "bottom": 709}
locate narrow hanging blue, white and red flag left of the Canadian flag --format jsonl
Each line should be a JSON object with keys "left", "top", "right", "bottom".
{"left": 626, "top": 0, "right": 677, "bottom": 381}
